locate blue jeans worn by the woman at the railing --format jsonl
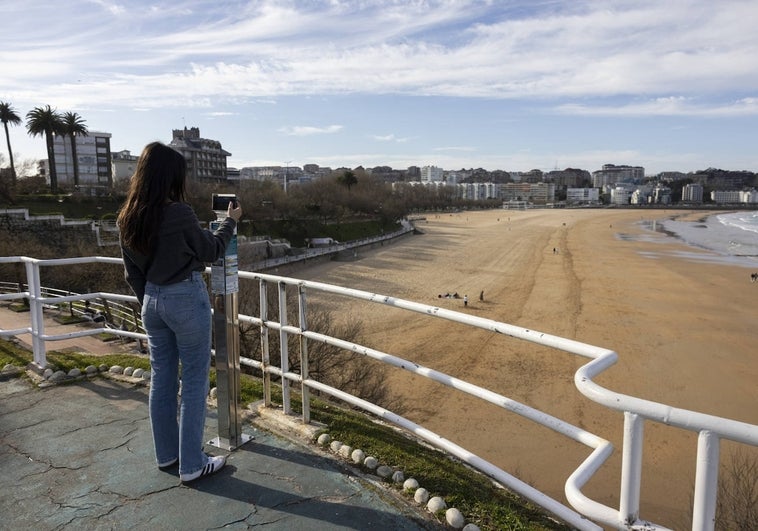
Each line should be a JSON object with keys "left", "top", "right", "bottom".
{"left": 142, "top": 271, "right": 211, "bottom": 474}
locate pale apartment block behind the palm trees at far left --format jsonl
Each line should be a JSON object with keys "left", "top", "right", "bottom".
{"left": 48, "top": 131, "right": 113, "bottom": 190}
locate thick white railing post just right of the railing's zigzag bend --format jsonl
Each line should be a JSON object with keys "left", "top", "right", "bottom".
{"left": 619, "top": 411, "right": 645, "bottom": 525}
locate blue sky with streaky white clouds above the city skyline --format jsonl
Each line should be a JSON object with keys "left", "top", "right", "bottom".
{"left": 0, "top": 0, "right": 758, "bottom": 175}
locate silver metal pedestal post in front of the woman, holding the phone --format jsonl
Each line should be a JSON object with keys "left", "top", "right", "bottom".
{"left": 209, "top": 212, "right": 252, "bottom": 450}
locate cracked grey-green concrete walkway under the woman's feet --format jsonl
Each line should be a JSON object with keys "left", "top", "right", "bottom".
{"left": 0, "top": 309, "right": 443, "bottom": 530}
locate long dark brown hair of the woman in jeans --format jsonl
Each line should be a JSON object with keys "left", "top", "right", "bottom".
{"left": 117, "top": 142, "right": 187, "bottom": 256}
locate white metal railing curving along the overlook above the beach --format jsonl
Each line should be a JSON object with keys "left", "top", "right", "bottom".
{"left": 0, "top": 257, "right": 758, "bottom": 531}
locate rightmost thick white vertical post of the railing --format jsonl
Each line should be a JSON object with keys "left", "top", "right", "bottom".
{"left": 692, "top": 430, "right": 721, "bottom": 531}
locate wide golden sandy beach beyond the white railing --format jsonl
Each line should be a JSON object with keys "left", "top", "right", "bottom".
{"left": 288, "top": 210, "right": 758, "bottom": 529}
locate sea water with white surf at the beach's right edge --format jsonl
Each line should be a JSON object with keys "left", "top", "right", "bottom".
{"left": 654, "top": 211, "right": 758, "bottom": 268}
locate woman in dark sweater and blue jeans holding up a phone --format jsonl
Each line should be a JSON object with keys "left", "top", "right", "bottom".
{"left": 118, "top": 142, "right": 242, "bottom": 482}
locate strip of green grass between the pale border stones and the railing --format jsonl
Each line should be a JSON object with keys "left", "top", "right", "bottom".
{"left": 0, "top": 340, "right": 570, "bottom": 531}
